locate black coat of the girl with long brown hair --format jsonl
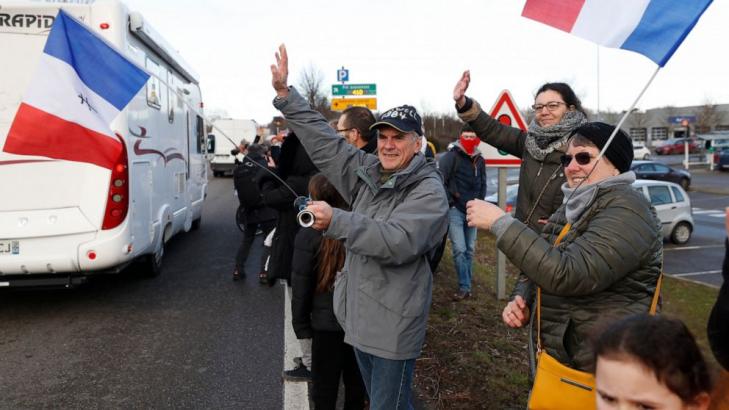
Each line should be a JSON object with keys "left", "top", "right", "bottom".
{"left": 291, "top": 228, "right": 342, "bottom": 339}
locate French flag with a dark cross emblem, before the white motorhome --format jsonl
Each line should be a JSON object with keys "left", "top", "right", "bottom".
{"left": 3, "top": 10, "right": 149, "bottom": 169}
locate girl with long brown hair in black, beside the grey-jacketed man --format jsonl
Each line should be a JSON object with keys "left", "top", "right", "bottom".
{"left": 291, "top": 174, "right": 366, "bottom": 410}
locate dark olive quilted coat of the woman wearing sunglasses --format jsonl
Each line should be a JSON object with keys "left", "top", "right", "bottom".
{"left": 497, "top": 183, "right": 663, "bottom": 370}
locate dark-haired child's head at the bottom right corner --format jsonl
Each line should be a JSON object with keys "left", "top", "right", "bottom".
{"left": 594, "top": 314, "right": 711, "bottom": 409}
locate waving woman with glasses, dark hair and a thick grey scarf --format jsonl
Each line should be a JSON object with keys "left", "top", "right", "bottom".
{"left": 453, "top": 71, "right": 587, "bottom": 342}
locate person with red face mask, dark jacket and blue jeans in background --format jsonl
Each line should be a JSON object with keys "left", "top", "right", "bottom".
{"left": 438, "top": 124, "right": 486, "bottom": 300}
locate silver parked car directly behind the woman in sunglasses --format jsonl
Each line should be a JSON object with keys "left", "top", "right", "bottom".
{"left": 633, "top": 179, "right": 694, "bottom": 245}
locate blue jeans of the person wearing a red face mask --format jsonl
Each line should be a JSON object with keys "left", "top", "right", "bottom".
{"left": 448, "top": 206, "right": 476, "bottom": 292}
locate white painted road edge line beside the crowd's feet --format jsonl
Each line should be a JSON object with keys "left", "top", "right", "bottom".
{"left": 283, "top": 283, "right": 309, "bottom": 410}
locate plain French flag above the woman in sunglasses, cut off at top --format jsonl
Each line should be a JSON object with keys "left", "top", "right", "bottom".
{"left": 522, "top": 0, "right": 711, "bottom": 67}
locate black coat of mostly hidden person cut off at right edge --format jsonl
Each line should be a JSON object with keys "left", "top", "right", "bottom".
{"left": 708, "top": 238, "right": 729, "bottom": 370}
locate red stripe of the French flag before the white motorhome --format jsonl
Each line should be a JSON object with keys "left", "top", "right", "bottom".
{"left": 3, "top": 103, "right": 122, "bottom": 169}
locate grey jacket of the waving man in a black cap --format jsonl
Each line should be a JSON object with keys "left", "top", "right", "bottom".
{"left": 274, "top": 88, "right": 448, "bottom": 360}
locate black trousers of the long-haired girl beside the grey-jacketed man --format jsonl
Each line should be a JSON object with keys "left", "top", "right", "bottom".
{"left": 311, "top": 330, "right": 366, "bottom": 410}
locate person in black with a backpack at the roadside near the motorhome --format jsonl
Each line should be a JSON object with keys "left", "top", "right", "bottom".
{"left": 233, "top": 144, "right": 277, "bottom": 280}
